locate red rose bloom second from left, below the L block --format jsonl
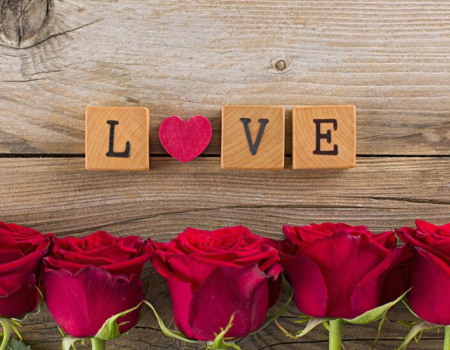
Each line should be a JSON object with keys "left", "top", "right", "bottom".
{"left": 44, "top": 231, "right": 149, "bottom": 338}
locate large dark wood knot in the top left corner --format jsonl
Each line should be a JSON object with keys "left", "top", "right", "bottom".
{"left": 0, "top": 0, "right": 51, "bottom": 48}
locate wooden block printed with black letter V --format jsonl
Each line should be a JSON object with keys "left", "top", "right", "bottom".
{"left": 222, "top": 106, "right": 285, "bottom": 169}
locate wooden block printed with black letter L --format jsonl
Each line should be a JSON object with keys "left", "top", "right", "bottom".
{"left": 86, "top": 107, "right": 150, "bottom": 171}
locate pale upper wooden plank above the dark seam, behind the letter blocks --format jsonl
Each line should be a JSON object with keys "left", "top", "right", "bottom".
{"left": 0, "top": 0, "right": 450, "bottom": 155}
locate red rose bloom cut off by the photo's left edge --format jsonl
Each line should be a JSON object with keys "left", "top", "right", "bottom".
{"left": 0, "top": 222, "right": 50, "bottom": 318}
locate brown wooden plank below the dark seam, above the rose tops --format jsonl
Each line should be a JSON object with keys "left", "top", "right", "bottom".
{"left": 0, "top": 157, "right": 450, "bottom": 240}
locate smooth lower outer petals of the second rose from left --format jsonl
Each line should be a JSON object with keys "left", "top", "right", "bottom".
{"left": 44, "top": 267, "right": 144, "bottom": 338}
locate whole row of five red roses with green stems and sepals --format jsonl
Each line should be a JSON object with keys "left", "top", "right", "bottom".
{"left": 0, "top": 221, "right": 450, "bottom": 350}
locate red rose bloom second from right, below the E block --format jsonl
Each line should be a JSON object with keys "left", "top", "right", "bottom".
{"left": 280, "top": 223, "right": 408, "bottom": 319}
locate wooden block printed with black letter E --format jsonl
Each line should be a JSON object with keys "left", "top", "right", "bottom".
{"left": 292, "top": 106, "right": 356, "bottom": 169}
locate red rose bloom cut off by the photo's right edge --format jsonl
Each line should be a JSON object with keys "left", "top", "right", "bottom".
{"left": 397, "top": 220, "right": 450, "bottom": 326}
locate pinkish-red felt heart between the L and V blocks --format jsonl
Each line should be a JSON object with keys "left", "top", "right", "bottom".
{"left": 159, "top": 115, "right": 212, "bottom": 163}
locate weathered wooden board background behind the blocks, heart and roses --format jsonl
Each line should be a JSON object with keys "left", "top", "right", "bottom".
{"left": 0, "top": 0, "right": 450, "bottom": 350}
